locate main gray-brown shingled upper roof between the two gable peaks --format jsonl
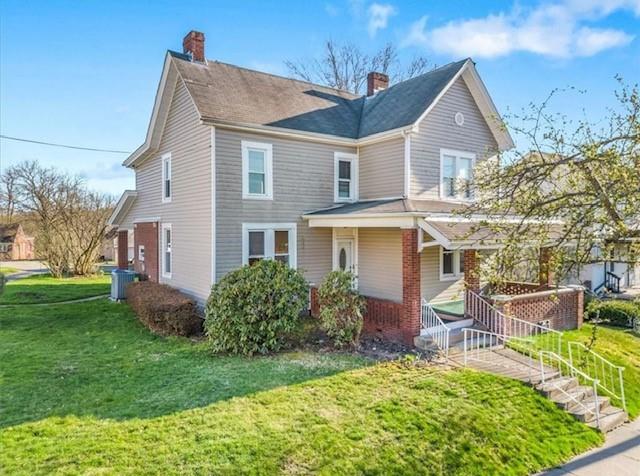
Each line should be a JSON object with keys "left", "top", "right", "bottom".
{"left": 169, "top": 52, "right": 466, "bottom": 139}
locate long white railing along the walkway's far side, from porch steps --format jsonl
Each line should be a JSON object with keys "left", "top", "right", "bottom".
{"left": 465, "top": 289, "right": 562, "bottom": 354}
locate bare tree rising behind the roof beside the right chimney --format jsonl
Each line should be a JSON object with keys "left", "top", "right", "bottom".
{"left": 285, "top": 40, "right": 431, "bottom": 94}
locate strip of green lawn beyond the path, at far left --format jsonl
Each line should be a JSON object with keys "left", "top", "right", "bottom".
{"left": 0, "top": 274, "right": 111, "bottom": 304}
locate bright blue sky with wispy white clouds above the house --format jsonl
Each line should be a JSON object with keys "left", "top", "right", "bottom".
{"left": 0, "top": 0, "right": 640, "bottom": 195}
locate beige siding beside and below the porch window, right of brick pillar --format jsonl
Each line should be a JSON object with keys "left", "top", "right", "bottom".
{"left": 420, "top": 246, "right": 464, "bottom": 302}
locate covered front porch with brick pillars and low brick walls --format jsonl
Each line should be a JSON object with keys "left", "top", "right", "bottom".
{"left": 305, "top": 200, "right": 583, "bottom": 345}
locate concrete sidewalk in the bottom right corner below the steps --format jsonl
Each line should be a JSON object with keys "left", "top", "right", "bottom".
{"left": 542, "top": 418, "right": 640, "bottom": 476}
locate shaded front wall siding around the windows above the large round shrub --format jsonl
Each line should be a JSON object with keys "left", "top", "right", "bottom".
{"left": 216, "top": 127, "right": 356, "bottom": 283}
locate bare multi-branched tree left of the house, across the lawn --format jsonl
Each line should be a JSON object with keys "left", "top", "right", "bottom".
{"left": 3, "top": 161, "right": 113, "bottom": 277}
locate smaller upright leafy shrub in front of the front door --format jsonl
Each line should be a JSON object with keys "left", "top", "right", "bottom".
{"left": 318, "top": 271, "right": 365, "bottom": 347}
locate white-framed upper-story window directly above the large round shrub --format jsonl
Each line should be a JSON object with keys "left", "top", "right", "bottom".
{"left": 242, "top": 141, "right": 273, "bottom": 200}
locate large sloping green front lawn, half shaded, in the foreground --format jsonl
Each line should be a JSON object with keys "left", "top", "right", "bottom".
{"left": 0, "top": 300, "right": 602, "bottom": 475}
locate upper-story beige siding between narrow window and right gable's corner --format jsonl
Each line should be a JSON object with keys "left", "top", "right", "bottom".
{"left": 358, "top": 137, "right": 404, "bottom": 200}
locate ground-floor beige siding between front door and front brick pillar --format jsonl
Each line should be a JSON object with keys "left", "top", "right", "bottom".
{"left": 358, "top": 228, "right": 402, "bottom": 302}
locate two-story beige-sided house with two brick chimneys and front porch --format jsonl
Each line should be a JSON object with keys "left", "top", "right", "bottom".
{"left": 110, "top": 32, "right": 582, "bottom": 343}
